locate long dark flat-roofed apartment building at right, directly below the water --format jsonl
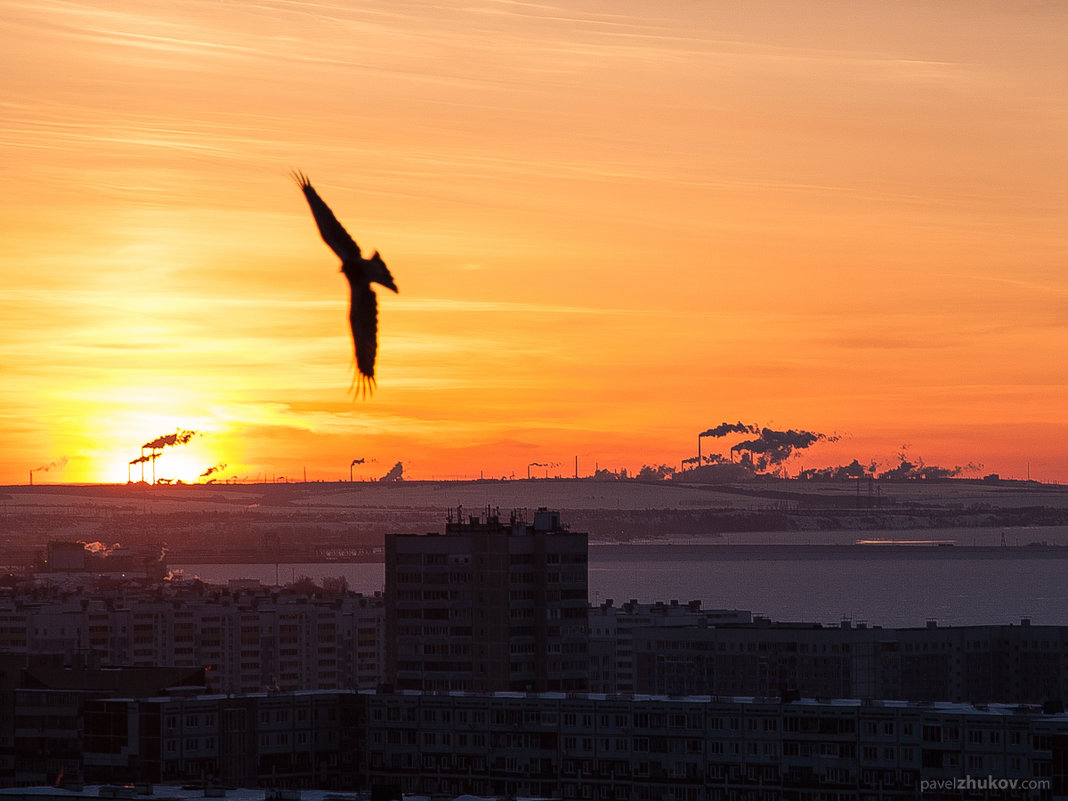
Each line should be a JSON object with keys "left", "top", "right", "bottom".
{"left": 631, "top": 618, "right": 1068, "bottom": 703}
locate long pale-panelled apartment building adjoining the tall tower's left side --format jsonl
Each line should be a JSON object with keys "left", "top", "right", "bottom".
{"left": 0, "top": 583, "right": 384, "bottom": 693}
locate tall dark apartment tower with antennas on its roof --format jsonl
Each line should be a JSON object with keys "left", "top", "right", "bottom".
{"left": 386, "top": 508, "right": 588, "bottom": 692}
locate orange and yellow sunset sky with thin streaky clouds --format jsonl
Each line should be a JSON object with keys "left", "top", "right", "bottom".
{"left": 0, "top": 0, "right": 1068, "bottom": 484}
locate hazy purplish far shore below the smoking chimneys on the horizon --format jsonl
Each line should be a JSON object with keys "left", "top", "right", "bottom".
{"left": 0, "top": 477, "right": 1068, "bottom": 568}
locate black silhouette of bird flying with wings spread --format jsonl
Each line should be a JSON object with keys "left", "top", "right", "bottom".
{"left": 293, "top": 172, "right": 397, "bottom": 395}
